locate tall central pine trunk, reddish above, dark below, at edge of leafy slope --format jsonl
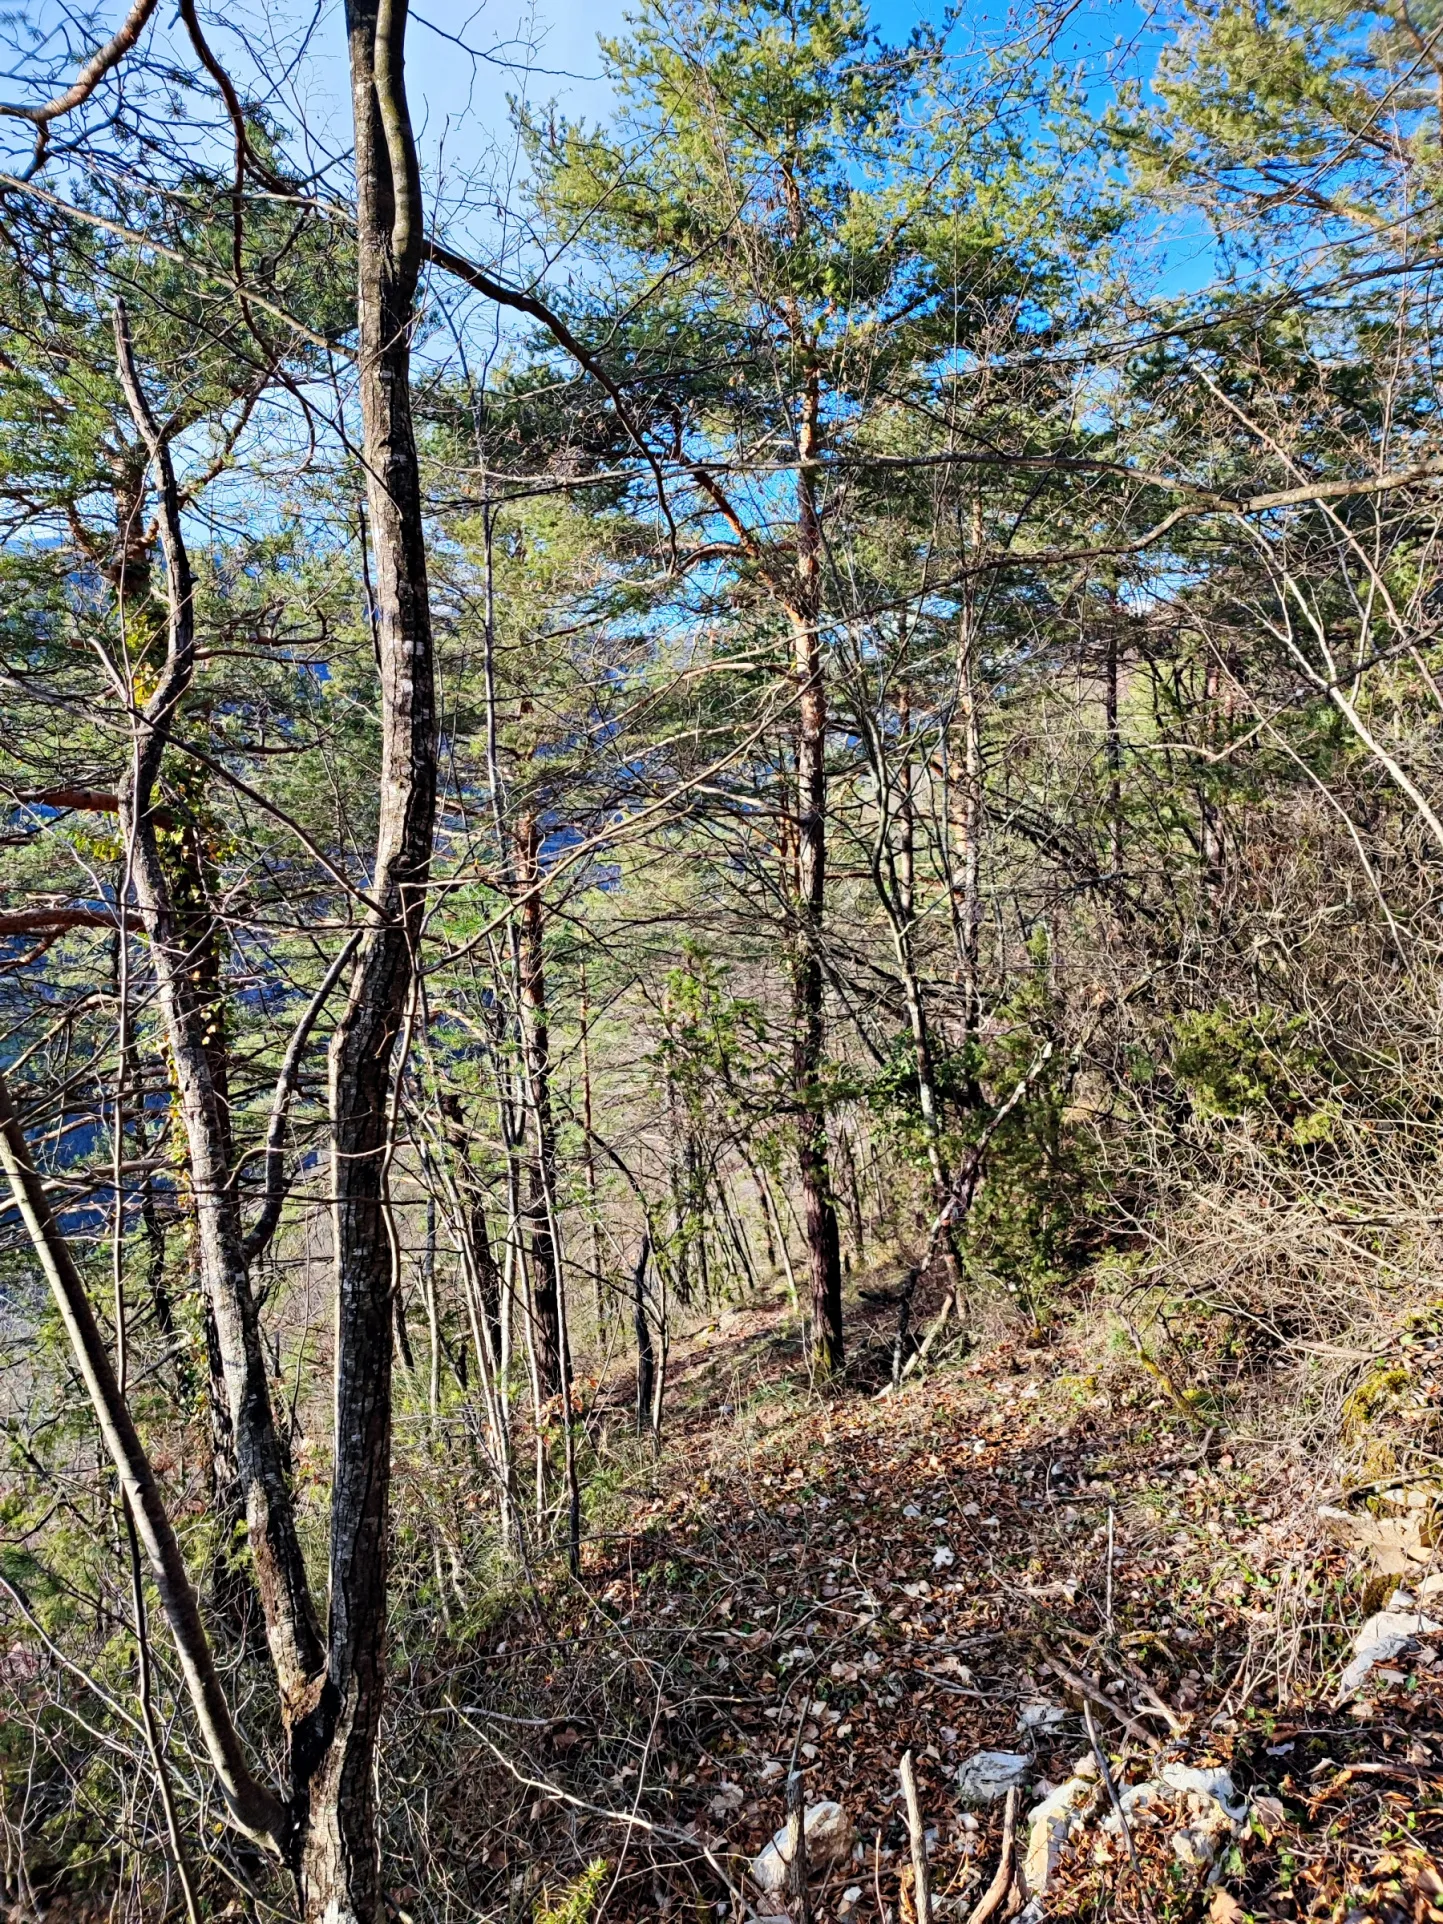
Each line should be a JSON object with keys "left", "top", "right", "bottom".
{"left": 789, "top": 369, "right": 843, "bottom": 1376}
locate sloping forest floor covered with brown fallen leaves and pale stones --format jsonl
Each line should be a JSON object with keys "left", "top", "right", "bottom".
{"left": 459, "top": 1299, "right": 1443, "bottom": 1924}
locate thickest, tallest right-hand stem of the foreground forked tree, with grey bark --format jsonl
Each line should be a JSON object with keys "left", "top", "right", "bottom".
{"left": 300, "top": 0, "right": 437, "bottom": 1924}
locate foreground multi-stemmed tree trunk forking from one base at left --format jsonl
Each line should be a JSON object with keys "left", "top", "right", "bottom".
{"left": 0, "top": 0, "right": 446, "bottom": 1924}
